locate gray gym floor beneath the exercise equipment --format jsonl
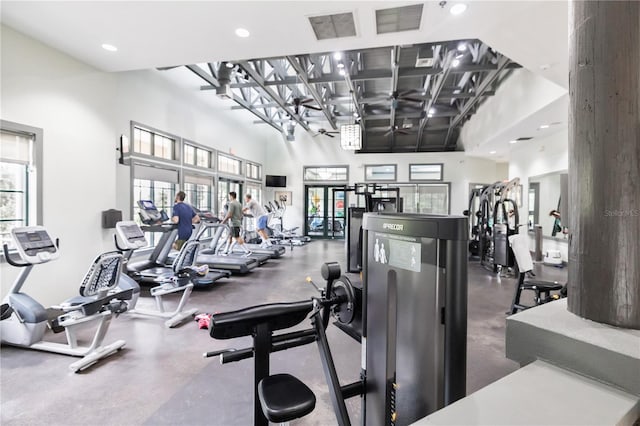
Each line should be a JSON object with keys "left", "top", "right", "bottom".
{"left": 0, "top": 241, "right": 566, "bottom": 425}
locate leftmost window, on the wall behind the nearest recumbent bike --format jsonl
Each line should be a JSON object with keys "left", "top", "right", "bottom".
{"left": 0, "top": 120, "right": 42, "bottom": 245}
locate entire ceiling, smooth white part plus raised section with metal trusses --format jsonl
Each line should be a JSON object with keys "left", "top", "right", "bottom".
{"left": 0, "top": 0, "right": 568, "bottom": 156}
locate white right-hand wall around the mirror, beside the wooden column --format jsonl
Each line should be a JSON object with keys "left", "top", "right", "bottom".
{"left": 509, "top": 126, "right": 569, "bottom": 261}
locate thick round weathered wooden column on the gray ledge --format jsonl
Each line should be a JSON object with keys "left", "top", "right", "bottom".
{"left": 561, "top": 0, "right": 640, "bottom": 329}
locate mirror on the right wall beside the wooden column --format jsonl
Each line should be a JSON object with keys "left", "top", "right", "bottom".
{"left": 527, "top": 170, "right": 569, "bottom": 240}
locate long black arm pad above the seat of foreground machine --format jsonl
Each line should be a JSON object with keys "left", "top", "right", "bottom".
{"left": 210, "top": 300, "right": 313, "bottom": 339}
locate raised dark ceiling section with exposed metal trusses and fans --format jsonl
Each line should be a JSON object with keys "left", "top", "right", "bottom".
{"left": 180, "top": 40, "right": 520, "bottom": 152}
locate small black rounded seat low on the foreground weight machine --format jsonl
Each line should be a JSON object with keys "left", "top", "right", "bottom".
{"left": 258, "top": 374, "right": 316, "bottom": 423}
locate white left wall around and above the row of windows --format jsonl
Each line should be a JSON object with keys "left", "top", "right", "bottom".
{"left": 0, "top": 26, "right": 265, "bottom": 306}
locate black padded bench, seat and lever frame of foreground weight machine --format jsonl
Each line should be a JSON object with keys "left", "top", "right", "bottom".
{"left": 204, "top": 262, "right": 364, "bottom": 426}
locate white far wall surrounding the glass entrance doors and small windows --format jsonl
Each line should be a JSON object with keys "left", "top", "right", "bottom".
{"left": 266, "top": 129, "right": 507, "bottom": 233}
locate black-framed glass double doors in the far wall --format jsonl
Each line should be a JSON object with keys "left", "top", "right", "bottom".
{"left": 305, "top": 185, "right": 347, "bottom": 238}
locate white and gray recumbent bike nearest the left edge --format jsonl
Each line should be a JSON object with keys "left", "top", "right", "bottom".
{"left": 0, "top": 226, "right": 132, "bottom": 373}
